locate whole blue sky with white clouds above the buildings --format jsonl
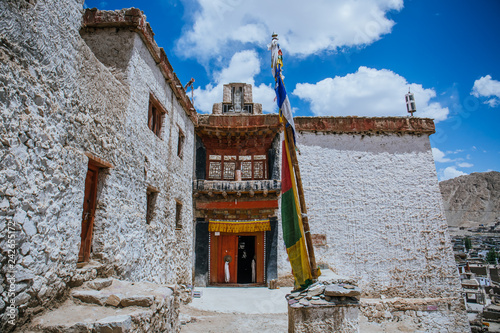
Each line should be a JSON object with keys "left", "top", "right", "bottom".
{"left": 85, "top": 0, "right": 500, "bottom": 180}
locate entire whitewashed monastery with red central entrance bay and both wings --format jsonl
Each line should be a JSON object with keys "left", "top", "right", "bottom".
{"left": 0, "top": 0, "right": 470, "bottom": 332}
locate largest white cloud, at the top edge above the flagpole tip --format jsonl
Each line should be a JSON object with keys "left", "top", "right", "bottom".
{"left": 177, "top": 0, "right": 403, "bottom": 60}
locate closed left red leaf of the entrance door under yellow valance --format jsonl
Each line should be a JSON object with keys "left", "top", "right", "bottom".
{"left": 217, "top": 234, "right": 238, "bottom": 283}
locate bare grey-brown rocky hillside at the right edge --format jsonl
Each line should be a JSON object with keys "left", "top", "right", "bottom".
{"left": 439, "top": 171, "right": 500, "bottom": 228}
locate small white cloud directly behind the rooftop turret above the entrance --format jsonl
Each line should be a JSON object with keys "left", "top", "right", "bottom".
{"left": 194, "top": 50, "right": 276, "bottom": 113}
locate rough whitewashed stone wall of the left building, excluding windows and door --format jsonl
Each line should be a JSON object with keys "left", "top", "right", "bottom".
{"left": 0, "top": 0, "right": 194, "bottom": 330}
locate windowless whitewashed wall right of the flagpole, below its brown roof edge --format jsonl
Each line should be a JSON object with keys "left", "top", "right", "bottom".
{"left": 279, "top": 130, "right": 468, "bottom": 332}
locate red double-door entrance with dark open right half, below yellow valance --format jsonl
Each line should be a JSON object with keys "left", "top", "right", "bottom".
{"left": 210, "top": 231, "right": 265, "bottom": 286}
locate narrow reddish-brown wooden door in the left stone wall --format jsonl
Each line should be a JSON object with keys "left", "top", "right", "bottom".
{"left": 78, "top": 163, "right": 99, "bottom": 262}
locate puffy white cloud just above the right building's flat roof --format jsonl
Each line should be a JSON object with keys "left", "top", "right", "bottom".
{"left": 293, "top": 66, "right": 449, "bottom": 122}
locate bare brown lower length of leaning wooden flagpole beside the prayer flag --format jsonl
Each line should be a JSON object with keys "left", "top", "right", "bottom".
{"left": 285, "top": 127, "right": 318, "bottom": 280}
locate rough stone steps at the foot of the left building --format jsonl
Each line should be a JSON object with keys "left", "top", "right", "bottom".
{"left": 22, "top": 279, "right": 180, "bottom": 333}
